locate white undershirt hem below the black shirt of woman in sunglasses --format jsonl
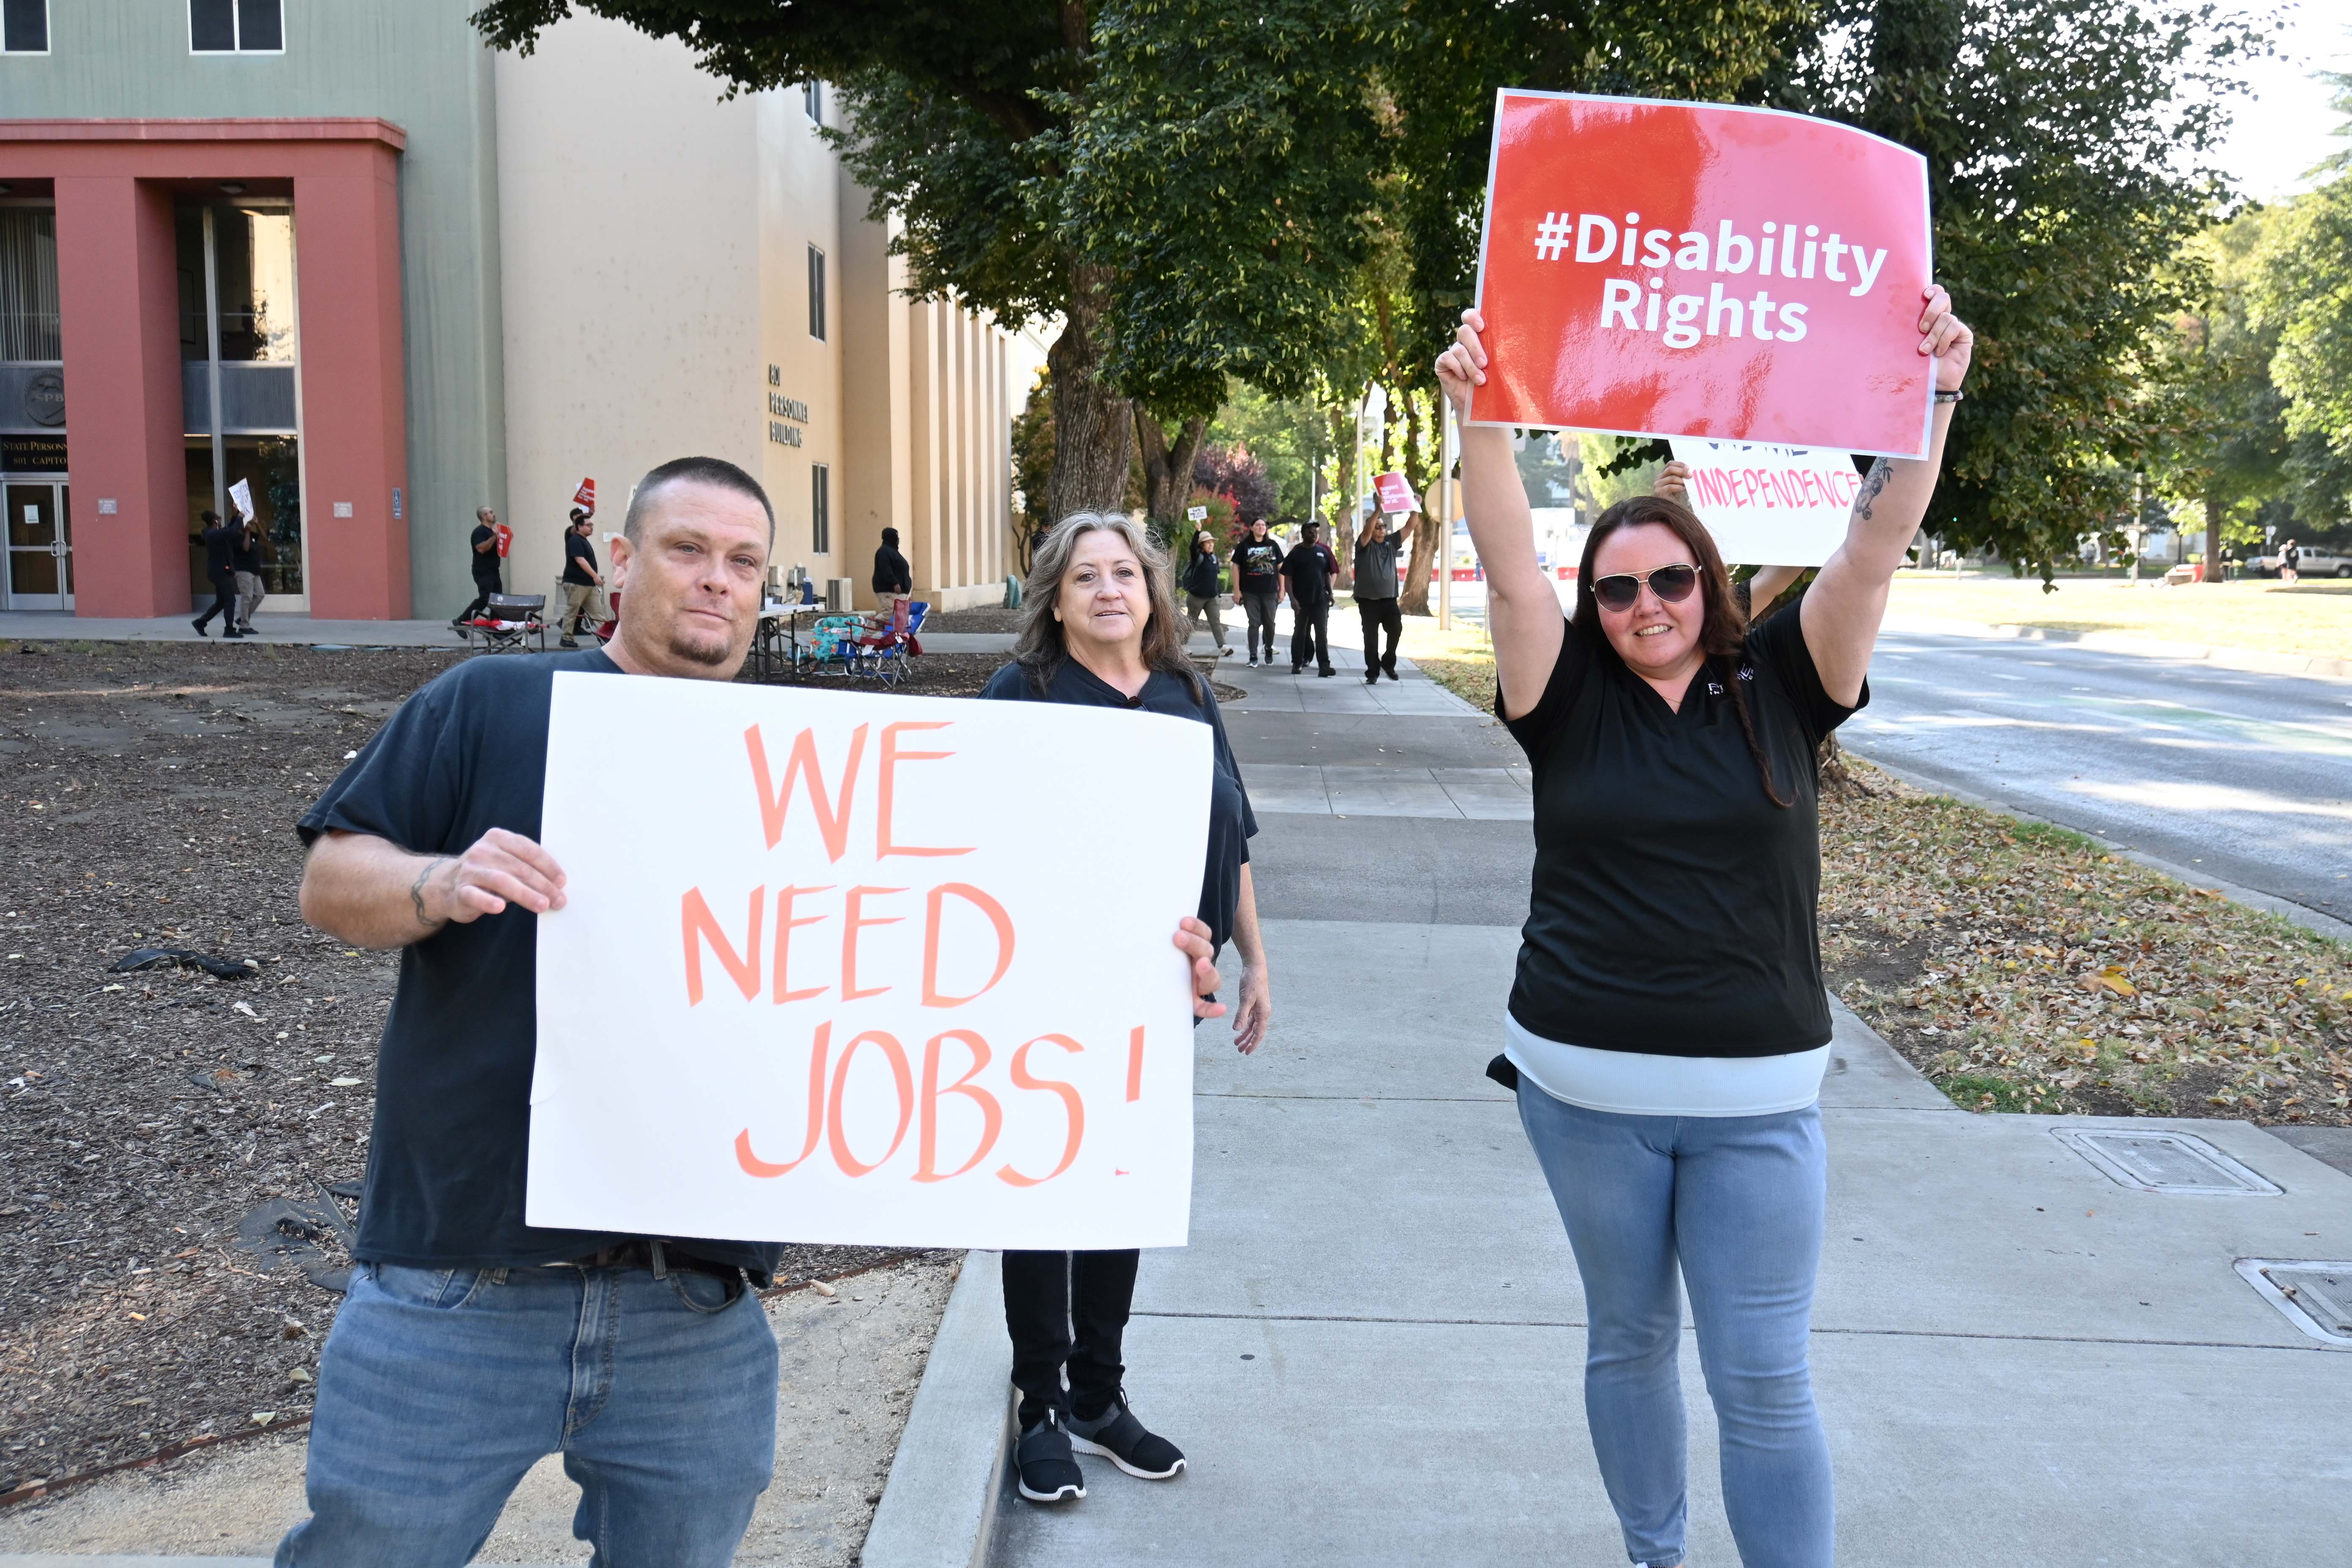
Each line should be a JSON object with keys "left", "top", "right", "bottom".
{"left": 1503, "top": 1008, "right": 1830, "bottom": 1116}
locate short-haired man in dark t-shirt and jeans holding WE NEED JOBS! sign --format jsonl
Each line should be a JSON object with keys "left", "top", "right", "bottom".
{"left": 278, "top": 458, "right": 1221, "bottom": 1565}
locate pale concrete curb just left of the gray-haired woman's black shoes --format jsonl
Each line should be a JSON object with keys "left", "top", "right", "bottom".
{"left": 866, "top": 1253, "right": 1014, "bottom": 1568}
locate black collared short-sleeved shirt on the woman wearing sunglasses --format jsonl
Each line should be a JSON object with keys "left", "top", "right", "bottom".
{"left": 1496, "top": 609, "right": 1870, "bottom": 1056}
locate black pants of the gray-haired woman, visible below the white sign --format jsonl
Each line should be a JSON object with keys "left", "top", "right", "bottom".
{"left": 1004, "top": 1248, "right": 1141, "bottom": 1427}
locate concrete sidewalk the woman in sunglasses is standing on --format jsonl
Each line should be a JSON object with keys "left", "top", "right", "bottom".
{"left": 959, "top": 700, "right": 2352, "bottom": 1568}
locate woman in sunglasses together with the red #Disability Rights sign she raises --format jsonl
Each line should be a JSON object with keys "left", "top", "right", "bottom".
{"left": 1437, "top": 94, "right": 1971, "bottom": 1565}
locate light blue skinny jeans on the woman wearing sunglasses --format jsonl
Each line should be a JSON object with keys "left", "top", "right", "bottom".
{"left": 1519, "top": 1077, "right": 1835, "bottom": 1568}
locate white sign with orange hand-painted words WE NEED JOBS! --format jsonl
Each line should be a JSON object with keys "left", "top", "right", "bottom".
{"left": 525, "top": 672, "right": 1211, "bottom": 1248}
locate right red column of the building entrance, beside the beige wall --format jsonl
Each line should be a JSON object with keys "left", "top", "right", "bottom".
{"left": 294, "top": 148, "right": 409, "bottom": 621}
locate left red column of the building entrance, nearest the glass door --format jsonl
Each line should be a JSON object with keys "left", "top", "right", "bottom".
{"left": 57, "top": 174, "right": 188, "bottom": 616}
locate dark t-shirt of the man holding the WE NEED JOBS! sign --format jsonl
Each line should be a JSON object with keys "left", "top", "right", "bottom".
{"left": 299, "top": 651, "right": 779, "bottom": 1281}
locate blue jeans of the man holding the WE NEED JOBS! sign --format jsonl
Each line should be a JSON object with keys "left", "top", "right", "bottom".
{"left": 278, "top": 1265, "right": 776, "bottom": 1568}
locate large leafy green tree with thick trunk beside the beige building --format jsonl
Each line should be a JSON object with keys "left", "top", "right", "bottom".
{"left": 475, "top": 0, "right": 1390, "bottom": 526}
